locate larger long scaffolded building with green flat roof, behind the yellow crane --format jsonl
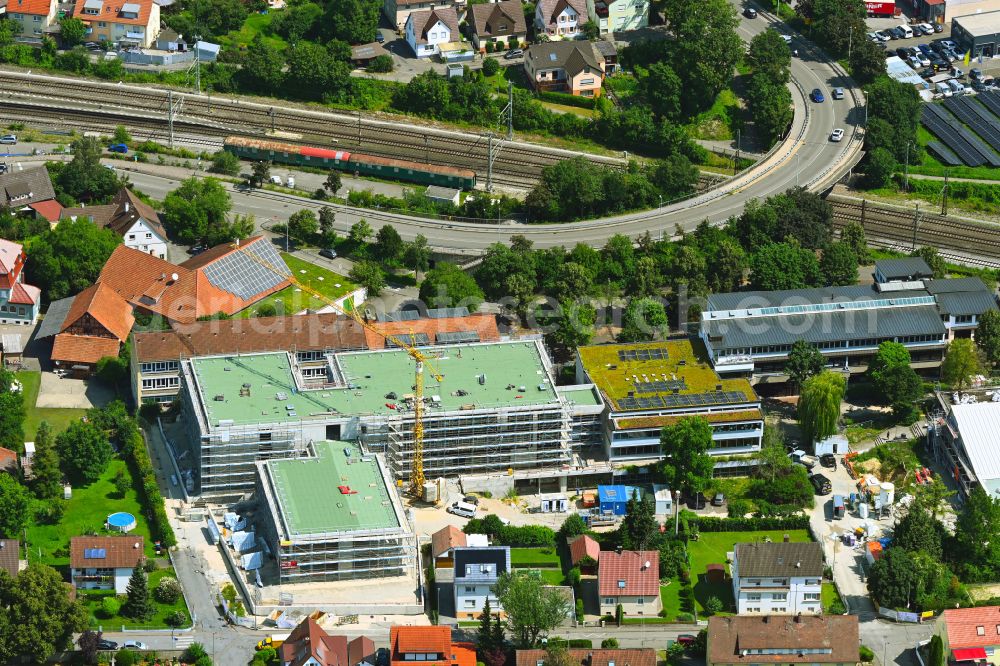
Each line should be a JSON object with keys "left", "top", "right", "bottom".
{"left": 181, "top": 340, "right": 574, "bottom": 499}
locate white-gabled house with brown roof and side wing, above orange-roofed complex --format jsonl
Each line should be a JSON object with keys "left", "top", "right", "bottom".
{"left": 62, "top": 187, "right": 167, "bottom": 259}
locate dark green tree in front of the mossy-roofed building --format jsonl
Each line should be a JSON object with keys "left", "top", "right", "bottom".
{"left": 660, "top": 416, "right": 714, "bottom": 493}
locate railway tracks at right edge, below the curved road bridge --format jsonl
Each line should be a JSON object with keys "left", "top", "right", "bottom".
{"left": 828, "top": 195, "right": 1000, "bottom": 268}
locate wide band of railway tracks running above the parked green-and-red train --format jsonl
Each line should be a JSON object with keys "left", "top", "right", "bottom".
{"left": 0, "top": 71, "right": 624, "bottom": 187}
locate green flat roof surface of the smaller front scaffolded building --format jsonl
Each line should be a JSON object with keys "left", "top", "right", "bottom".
{"left": 267, "top": 441, "right": 399, "bottom": 537}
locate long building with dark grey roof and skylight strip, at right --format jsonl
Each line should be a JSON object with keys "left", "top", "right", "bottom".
{"left": 699, "top": 274, "right": 997, "bottom": 382}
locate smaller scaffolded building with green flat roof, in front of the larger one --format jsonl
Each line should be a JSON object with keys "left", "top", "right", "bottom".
{"left": 256, "top": 441, "right": 417, "bottom": 584}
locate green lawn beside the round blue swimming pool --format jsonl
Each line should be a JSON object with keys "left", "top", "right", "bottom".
{"left": 27, "top": 459, "right": 154, "bottom": 578}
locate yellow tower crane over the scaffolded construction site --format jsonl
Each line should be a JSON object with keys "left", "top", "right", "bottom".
{"left": 238, "top": 245, "right": 444, "bottom": 497}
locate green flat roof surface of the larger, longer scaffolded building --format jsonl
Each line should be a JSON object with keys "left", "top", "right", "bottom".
{"left": 191, "top": 341, "right": 559, "bottom": 427}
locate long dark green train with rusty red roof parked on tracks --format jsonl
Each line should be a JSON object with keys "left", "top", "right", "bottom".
{"left": 223, "top": 136, "right": 476, "bottom": 190}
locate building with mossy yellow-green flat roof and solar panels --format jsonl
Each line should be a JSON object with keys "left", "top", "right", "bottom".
{"left": 576, "top": 339, "right": 764, "bottom": 461}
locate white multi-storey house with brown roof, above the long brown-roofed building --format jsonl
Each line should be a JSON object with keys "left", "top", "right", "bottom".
{"left": 732, "top": 542, "right": 823, "bottom": 615}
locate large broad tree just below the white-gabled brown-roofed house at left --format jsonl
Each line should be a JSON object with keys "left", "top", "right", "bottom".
{"left": 22, "top": 217, "right": 122, "bottom": 300}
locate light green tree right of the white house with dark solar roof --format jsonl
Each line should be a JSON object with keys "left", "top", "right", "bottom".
{"left": 493, "top": 571, "right": 570, "bottom": 648}
